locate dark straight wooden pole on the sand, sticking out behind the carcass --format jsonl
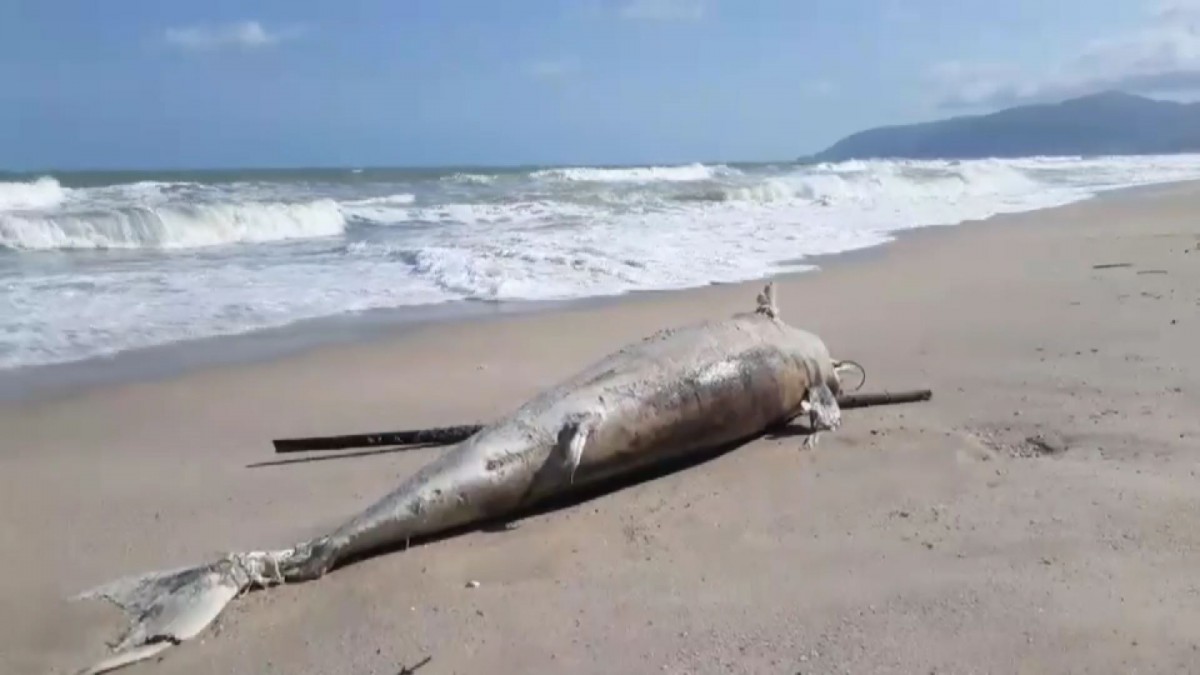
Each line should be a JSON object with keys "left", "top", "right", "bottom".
{"left": 274, "top": 389, "right": 934, "bottom": 454}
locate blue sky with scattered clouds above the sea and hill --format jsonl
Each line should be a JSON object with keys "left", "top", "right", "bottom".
{"left": 0, "top": 0, "right": 1200, "bottom": 171}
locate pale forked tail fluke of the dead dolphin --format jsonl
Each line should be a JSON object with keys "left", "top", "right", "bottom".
{"left": 73, "top": 550, "right": 298, "bottom": 675}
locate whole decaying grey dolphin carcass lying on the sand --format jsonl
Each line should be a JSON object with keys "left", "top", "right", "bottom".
{"left": 78, "top": 285, "right": 850, "bottom": 674}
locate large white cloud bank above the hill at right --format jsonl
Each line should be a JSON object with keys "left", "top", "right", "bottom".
{"left": 928, "top": 0, "right": 1200, "bottom": 108}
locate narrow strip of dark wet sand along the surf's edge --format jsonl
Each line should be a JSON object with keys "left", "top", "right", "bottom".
{"left": 7, "top": 180, "right": 1200, "bottom": 405}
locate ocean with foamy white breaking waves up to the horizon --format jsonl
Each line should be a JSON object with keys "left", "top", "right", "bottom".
{"left": 0, "top": 155, "right": 1200, "bottom": 370}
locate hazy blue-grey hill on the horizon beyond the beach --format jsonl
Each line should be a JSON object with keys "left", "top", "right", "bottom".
{"left": 800, "top": 91, "right": 1200, "bottom": 162}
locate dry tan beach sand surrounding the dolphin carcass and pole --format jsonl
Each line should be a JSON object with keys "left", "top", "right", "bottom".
{"left": 0, "top": 185, "right": 1200, "bottom": 675}
